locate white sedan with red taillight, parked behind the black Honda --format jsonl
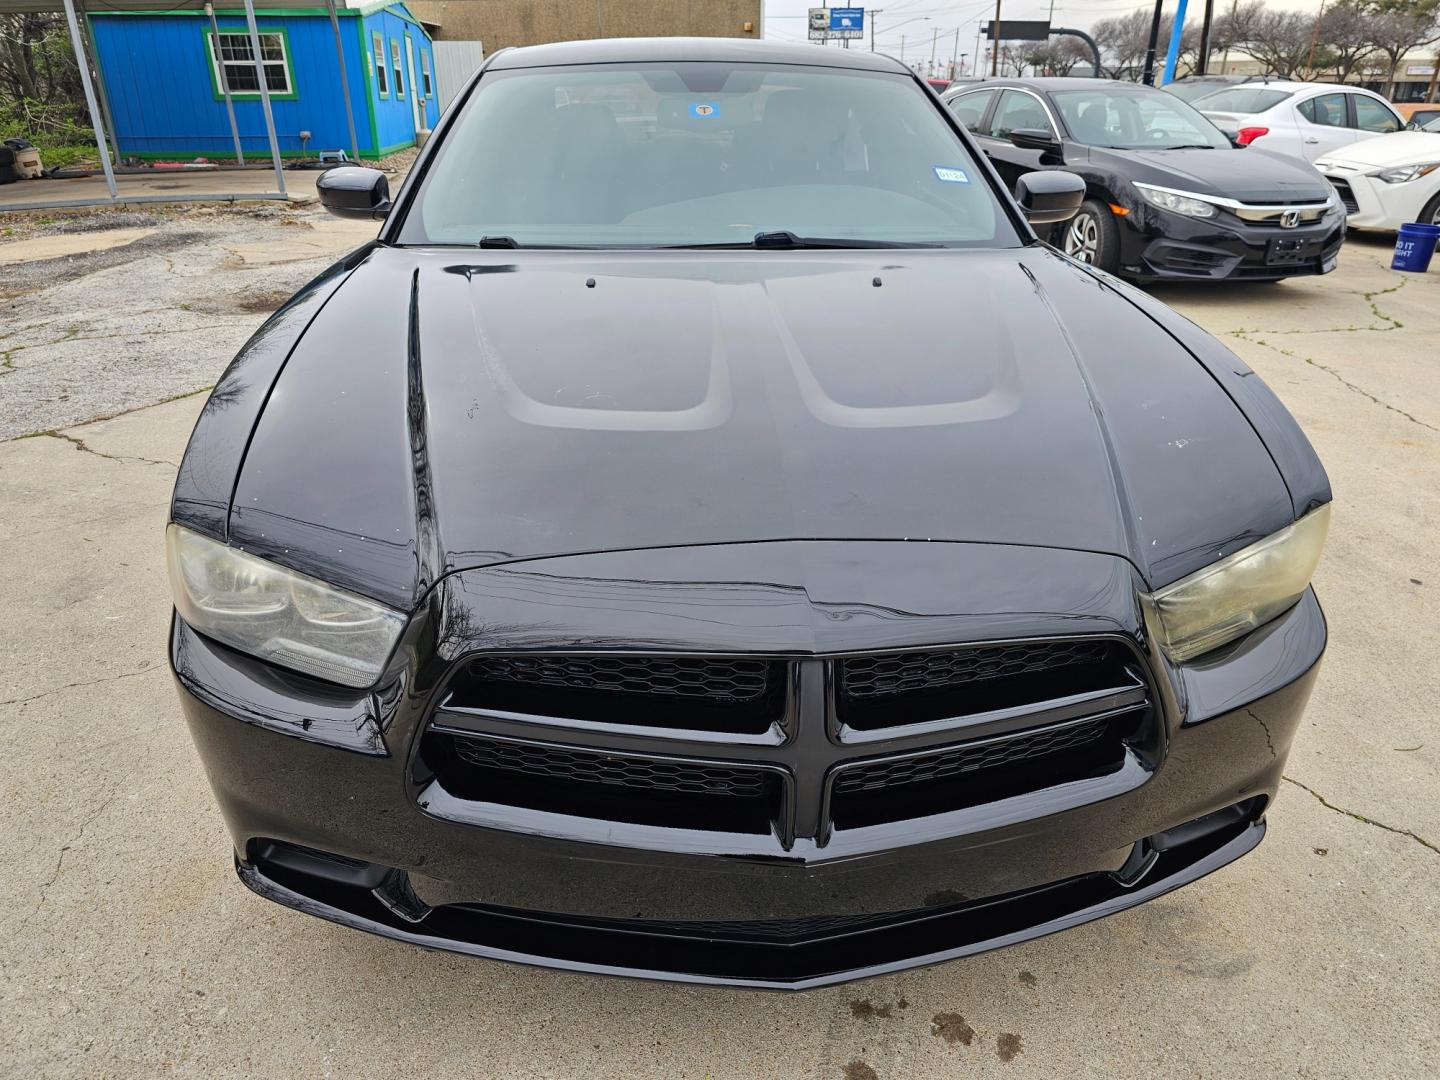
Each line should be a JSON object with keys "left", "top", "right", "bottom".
{"left": 1191, "top": 82, "right": 1405, "bottom": 161}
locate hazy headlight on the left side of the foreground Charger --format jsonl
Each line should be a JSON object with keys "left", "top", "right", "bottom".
{"left": 166, "top": 524, "right": 405, "bottom": 687}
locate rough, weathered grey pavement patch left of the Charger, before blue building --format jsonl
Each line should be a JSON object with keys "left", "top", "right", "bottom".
{"left": 0, "top": 204, "right": 374, "bottom": 439}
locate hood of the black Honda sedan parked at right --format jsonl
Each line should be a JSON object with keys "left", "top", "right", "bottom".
{"left": 1090, "top": 147, "right": 1331, "bottom": 204}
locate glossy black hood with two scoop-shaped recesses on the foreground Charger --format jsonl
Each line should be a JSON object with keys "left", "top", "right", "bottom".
{"left": 224, "top": 245, "right": 1293, "bottom": 606}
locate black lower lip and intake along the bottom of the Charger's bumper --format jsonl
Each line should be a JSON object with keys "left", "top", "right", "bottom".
{"left": 236, "top": 817, "right": 1266, "bottom": 989}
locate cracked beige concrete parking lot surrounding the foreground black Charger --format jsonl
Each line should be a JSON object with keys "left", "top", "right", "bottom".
{"left": 0, "top": 206, "right": 1440, "bottom": 1080}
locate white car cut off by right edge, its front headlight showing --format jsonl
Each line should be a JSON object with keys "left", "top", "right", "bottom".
{"left": 1315, "top": 120, "right": 1440, "bottom": 232}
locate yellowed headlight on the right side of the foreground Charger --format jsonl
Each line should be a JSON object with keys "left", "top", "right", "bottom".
{"left": 1149, "top": 503, "right": 1331, "bottom": 664}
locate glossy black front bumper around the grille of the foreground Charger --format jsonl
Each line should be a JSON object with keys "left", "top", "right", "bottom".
{"left": 171, "top": 552, "right": 1325, "bottom": 989}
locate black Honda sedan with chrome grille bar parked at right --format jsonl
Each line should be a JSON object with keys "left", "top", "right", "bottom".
{"left": 946, "top": 79, "right": 1345, "bottom": 281}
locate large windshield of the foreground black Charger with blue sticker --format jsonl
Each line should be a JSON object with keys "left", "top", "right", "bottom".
{"left": 399, "top": 63, "right": 1021, "bottom": 248}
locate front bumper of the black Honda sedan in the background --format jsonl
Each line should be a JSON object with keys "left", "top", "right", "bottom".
{"left": 1120, "top": 204, "right": 1345, "bottom": 281}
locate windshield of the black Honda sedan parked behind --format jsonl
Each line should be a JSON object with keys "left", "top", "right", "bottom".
{"left": 1050, "top": 88, "right": 1230, "bottom": 150}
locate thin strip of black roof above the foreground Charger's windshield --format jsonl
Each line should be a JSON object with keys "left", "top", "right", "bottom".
{"left": 490, "top": 37, "right": 913, "bottom": 75}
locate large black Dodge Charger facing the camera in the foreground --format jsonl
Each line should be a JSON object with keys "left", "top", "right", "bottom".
{"left": 168, "top": 39, "right": 1331, "bottom": 988}
